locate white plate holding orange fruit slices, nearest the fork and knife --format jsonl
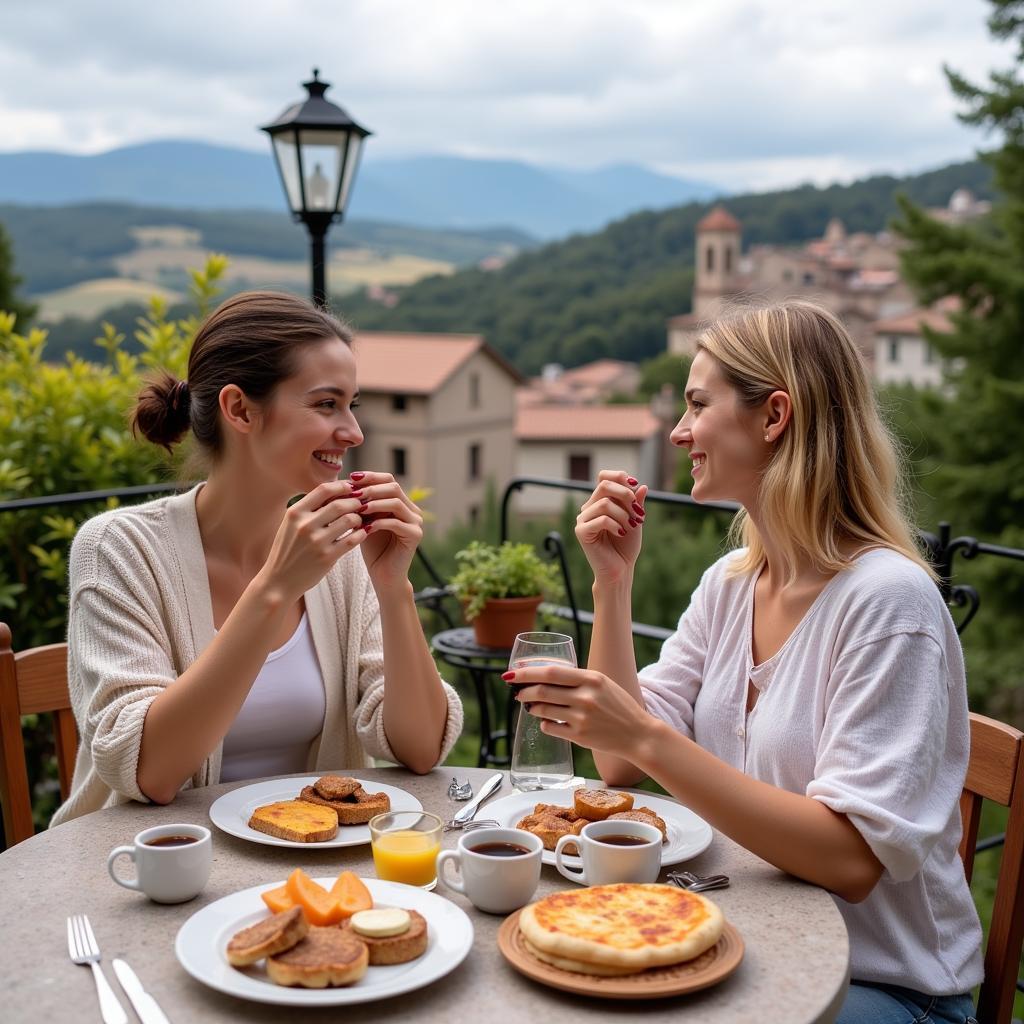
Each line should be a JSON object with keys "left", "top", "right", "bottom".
{"left": 174, "top": 878, "right": 473, "bottom": 1007}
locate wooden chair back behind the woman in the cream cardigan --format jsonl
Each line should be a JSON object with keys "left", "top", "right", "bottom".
{"left": 0, "top": 623, "right": 78, "bottom": 847}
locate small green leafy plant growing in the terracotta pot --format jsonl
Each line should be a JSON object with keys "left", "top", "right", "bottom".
{"left": 451, "top": 541, "right": 562, "bottom": 622}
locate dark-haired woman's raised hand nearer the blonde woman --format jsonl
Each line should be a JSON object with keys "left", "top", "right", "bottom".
{"left": 351, "top": 472, "right": 423, "bottom": 593}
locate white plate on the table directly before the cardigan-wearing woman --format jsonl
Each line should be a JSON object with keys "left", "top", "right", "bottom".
{"left": 210, "top": 775, "right": 423, "bottom": 850}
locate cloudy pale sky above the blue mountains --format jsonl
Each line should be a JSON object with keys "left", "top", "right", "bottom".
{"left": 0, "top": 0, "right": 1011, "bottom": 188}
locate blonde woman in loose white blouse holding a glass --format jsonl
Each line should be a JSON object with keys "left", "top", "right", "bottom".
{"left": 507, "top": 302, "right": 982, "bottom": 1022}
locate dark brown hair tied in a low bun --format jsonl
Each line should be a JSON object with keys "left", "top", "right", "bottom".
{"left": 131, "top": 292, "right": 352, "bottom": 460}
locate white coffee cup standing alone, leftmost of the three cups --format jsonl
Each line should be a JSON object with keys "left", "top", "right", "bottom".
{"left": 106, "top": 824, "right": 213, "bottom": 903}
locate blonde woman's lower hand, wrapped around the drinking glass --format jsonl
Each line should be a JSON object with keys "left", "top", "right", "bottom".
{"left": 502, "top": 665, "right": 651, "bottom": 760}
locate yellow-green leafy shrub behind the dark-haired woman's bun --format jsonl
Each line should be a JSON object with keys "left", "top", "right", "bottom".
{"left": 0, "top": 256, "right": 225, "bottom": 647}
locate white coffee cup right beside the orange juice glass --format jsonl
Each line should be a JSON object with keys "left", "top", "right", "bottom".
{"left": 437, "top": 828, "right": 544, "bottom": 913}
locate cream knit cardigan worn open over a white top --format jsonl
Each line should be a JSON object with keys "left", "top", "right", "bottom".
{"left": 51, "top": 484, "right": 462, "bottom": 825}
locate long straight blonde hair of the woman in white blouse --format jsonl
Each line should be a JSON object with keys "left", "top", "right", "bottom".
{"left": 697, "top": 301, "right": 936, "bottom": 582}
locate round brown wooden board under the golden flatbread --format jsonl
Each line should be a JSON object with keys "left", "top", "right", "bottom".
{"left": 498, "top": 910, "right": 743, "bottom": 999}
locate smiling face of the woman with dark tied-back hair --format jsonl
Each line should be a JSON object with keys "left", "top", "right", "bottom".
{"left": 250, "top": 338, "right": 362, "bottom": 495}
